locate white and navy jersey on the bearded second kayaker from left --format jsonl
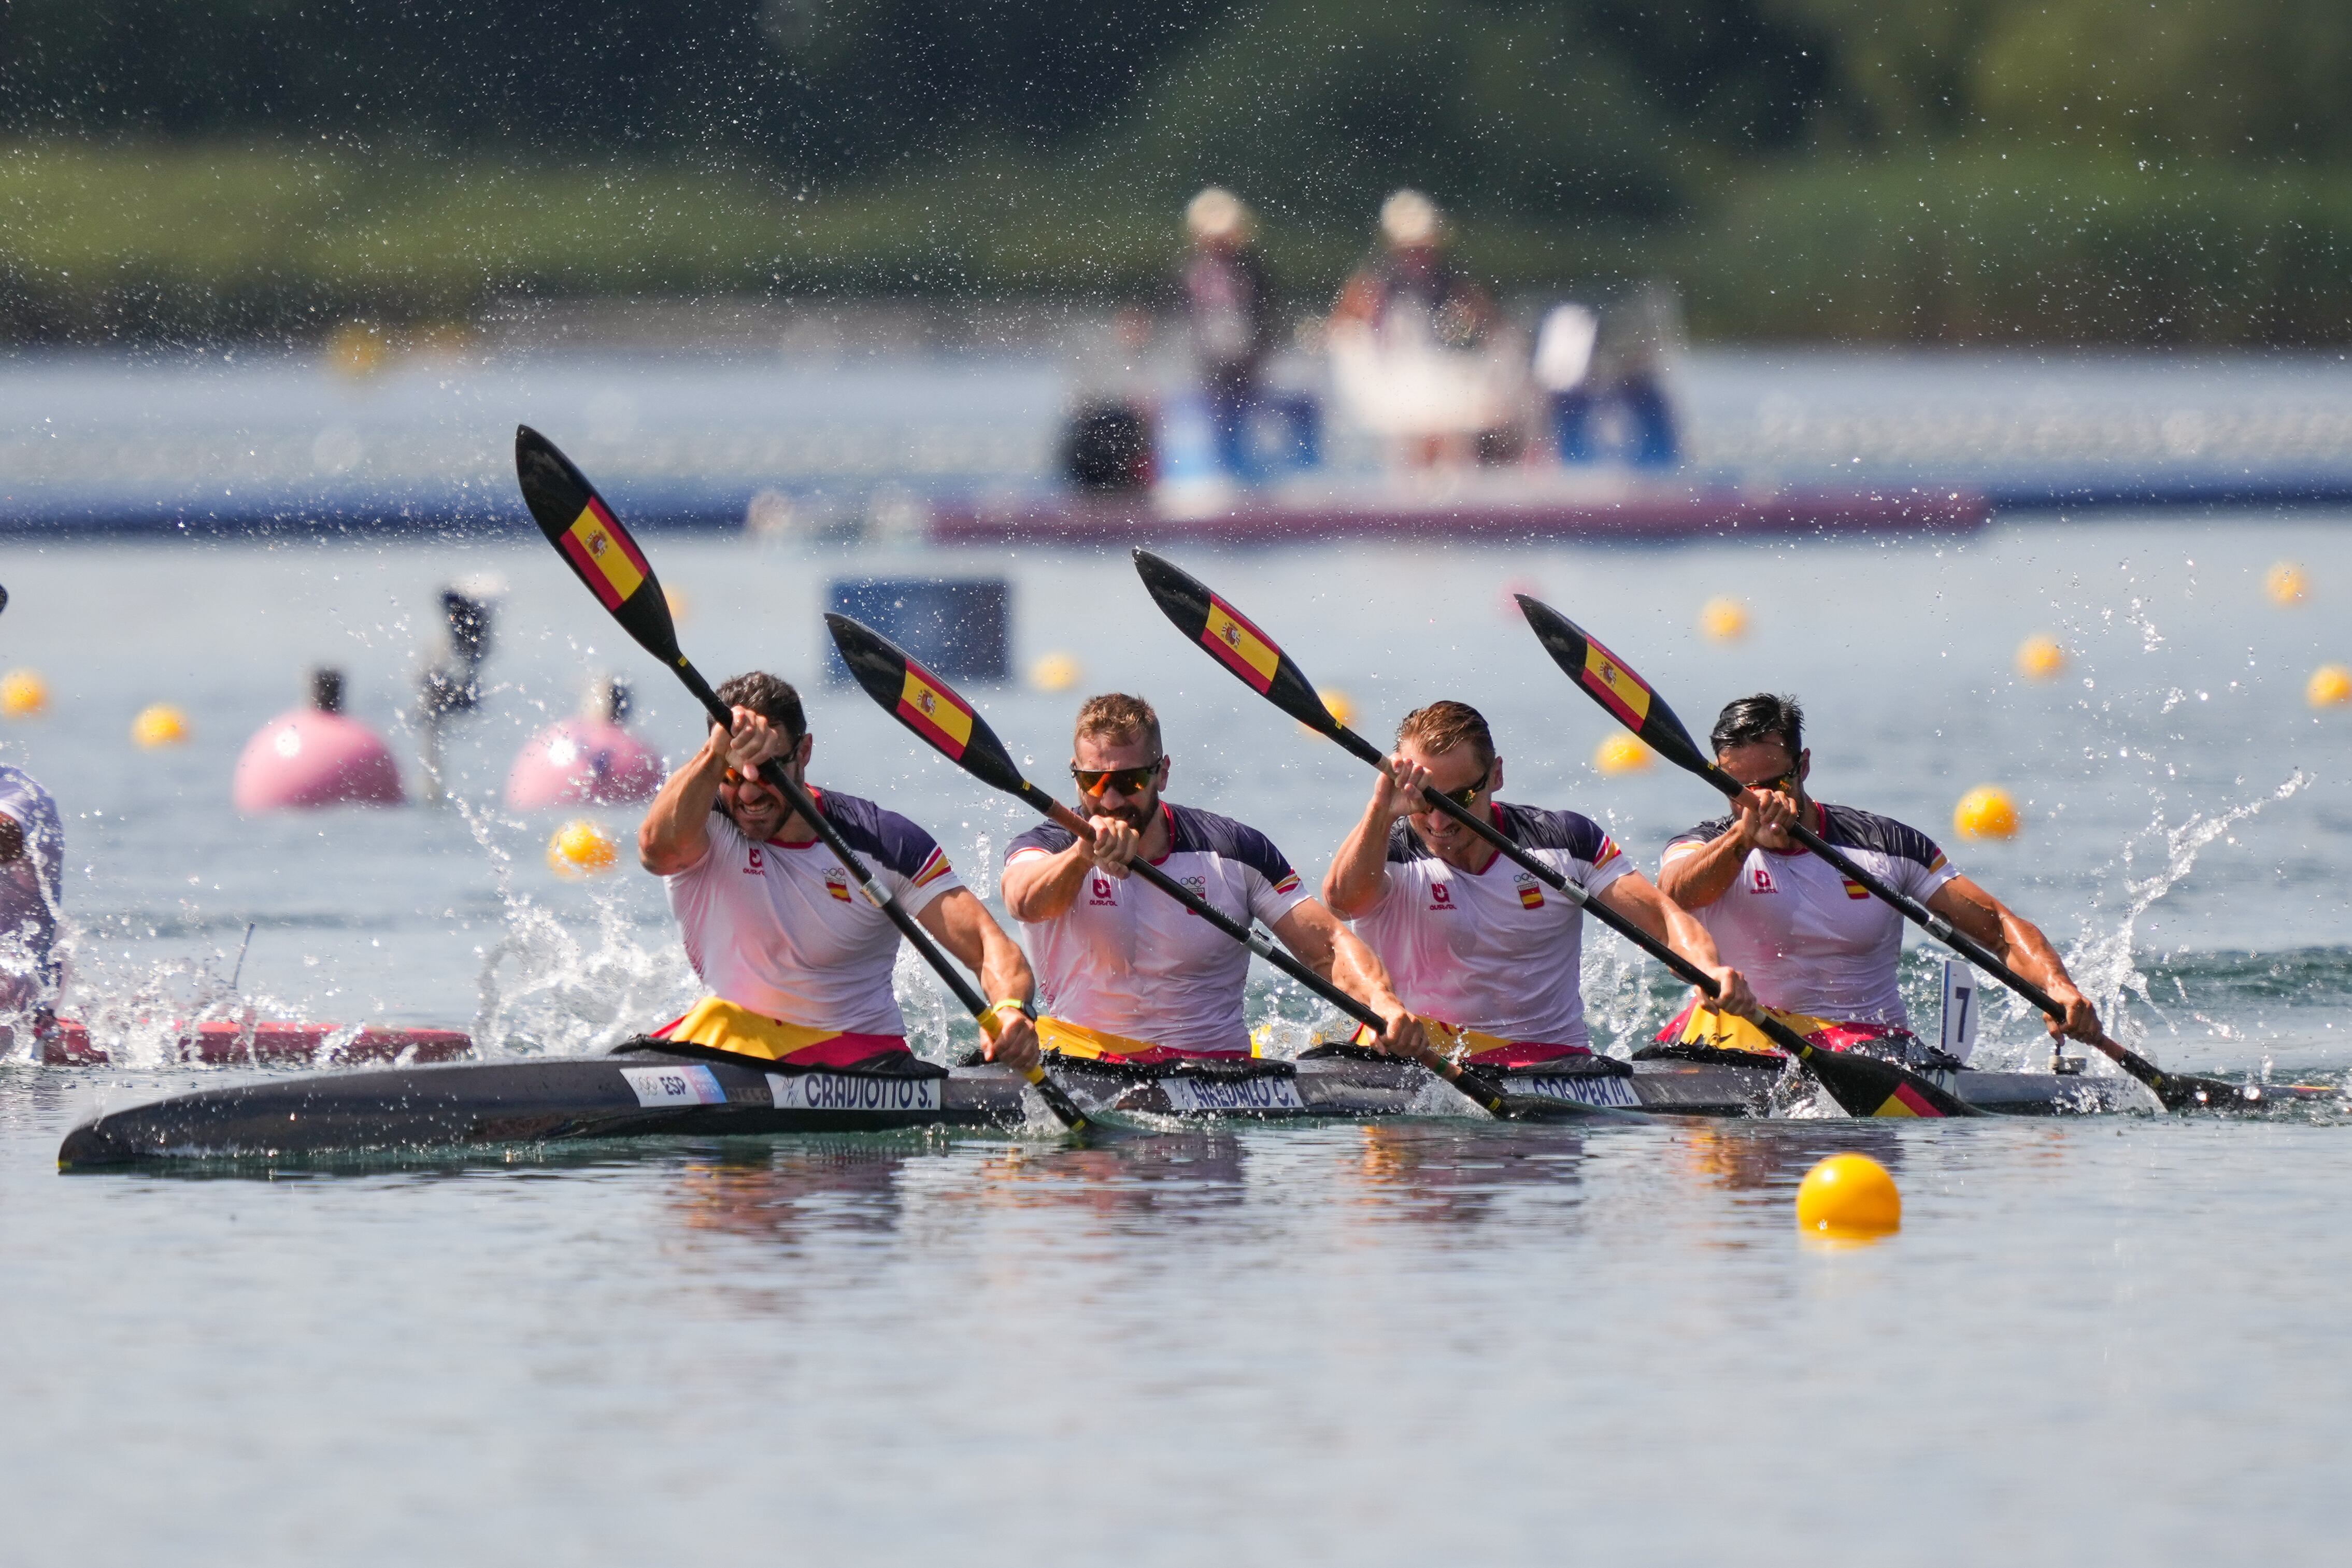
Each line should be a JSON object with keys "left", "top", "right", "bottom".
{"left": 1004, "top": 802, "right": 1308, "bottom": 1051}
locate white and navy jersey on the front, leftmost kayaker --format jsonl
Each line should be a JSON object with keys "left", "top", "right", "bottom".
{"left": 663, "top": 788, "right": 962, "bottom": 1034}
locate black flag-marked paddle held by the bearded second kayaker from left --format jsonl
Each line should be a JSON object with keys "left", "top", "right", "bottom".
{"left": 825, "top": 614, "right": 1623, "bottom": 1117}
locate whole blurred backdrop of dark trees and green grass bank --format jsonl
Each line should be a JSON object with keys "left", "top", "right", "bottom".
{"left": 0, "top": 0, "right": 2352, "bottom": 341}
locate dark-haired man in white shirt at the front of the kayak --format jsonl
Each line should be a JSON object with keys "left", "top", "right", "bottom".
{"left": 637, "top": 673, "right": 1037, "bottom": 1070}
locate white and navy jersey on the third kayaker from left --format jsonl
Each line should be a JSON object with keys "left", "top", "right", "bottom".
{"left": 1355, "top": 802, "right": 1632, "bottom": 1048}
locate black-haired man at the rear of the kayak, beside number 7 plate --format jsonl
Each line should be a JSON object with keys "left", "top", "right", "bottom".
{"left": 1658, "top": 691, "right": 2098, "bottom": 1065}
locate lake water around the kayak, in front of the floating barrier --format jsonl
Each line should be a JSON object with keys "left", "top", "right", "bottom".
{"left": 0, "top": 515, "right": 2352, "bottom": 1563}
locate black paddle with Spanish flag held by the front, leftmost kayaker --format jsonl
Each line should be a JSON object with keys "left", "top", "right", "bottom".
{"left": 515, "top": 425, "right": 1091, "bottom": 1133}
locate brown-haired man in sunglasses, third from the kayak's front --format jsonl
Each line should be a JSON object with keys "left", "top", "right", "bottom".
{"left": 1324, "top": 701, "right": 1755, "bottom": 1067}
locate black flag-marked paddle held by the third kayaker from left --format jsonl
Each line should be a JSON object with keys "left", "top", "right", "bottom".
{"left": 1136, "top": 550, "right": 1983, "bottom": 1117}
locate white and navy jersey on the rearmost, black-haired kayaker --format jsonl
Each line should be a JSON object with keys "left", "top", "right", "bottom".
{"left": 1665, "top": 802, "right": 1959, "bottom": 1030}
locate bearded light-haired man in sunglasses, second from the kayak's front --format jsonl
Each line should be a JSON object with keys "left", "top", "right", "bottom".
{"left": 1004, "top": 693, "right": 1423, "bottom": 1067}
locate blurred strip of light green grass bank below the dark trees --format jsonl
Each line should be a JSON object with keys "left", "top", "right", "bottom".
{"left": 0, "top": 141, "right": 2352, "bottom": 346}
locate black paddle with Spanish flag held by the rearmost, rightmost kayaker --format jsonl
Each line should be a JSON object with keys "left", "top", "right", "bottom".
{"left": 1517, "top": 592, "right": 2263, "bottom": 1109}
